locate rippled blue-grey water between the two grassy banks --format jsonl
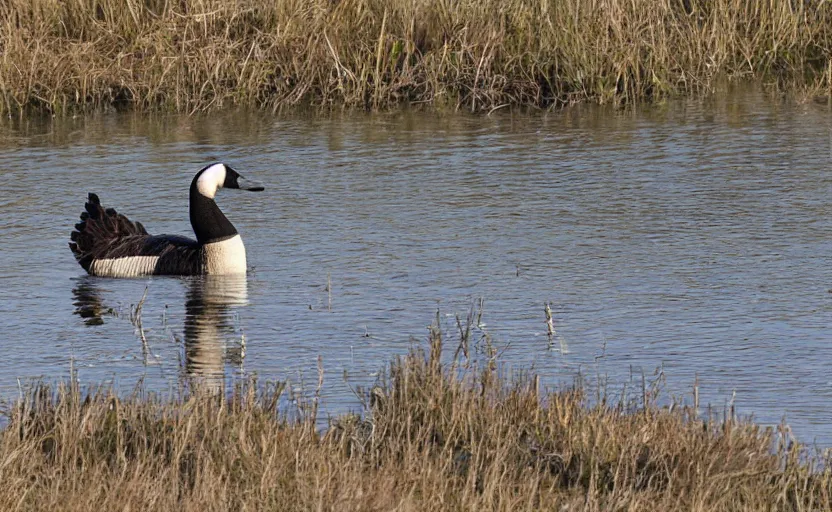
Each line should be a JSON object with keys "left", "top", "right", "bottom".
{"left": 0, "top": 93, "right": 832, "bottom": 446}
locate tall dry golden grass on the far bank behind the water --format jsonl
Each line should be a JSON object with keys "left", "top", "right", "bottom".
{"left": 0, "top": 0, "right": 832, "bottom": 114}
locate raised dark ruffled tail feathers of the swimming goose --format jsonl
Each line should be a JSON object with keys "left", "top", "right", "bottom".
{"left": 69, "top": 193, "right": 149, "bottom": 272}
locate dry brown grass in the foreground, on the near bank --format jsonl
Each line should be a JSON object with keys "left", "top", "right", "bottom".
{"left": 0, "top": 331, "right": 832, "bottom": 511}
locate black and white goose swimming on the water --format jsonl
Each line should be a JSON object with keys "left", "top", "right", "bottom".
{"left": 69, "top": 162, "right": 263, "bottom": 277}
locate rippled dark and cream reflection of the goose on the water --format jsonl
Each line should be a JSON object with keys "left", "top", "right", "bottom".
{"left": 72, "top": 275, "right": 248, "bottom": 393}
